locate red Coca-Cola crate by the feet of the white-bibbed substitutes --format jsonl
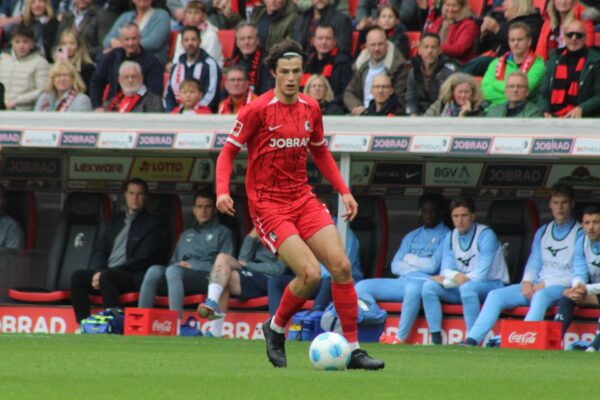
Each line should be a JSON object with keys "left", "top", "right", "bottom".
{"left": 500, "top": 319, "right": 562, "bottom": 350}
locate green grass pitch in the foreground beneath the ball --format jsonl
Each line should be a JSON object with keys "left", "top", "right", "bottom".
{"left": 0, "top": 334, "right": 600, "bottom": 400}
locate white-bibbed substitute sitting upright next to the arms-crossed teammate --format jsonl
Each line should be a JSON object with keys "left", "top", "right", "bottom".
{"left": 421, "top": 197, "right": 508, "bottom": 344}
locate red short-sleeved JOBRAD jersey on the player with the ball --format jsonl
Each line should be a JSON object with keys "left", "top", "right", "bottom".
{"left": 217, "top": 90, "right": 348, "bottom": 208}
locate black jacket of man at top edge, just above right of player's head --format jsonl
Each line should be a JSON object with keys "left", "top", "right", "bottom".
{"left": 292, "top": 6, "right": 352, "bottom": 53}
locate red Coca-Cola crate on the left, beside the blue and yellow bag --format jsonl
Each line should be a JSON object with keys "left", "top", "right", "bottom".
{"left": 123, "top": 308, "right": 179, "bottom": 336}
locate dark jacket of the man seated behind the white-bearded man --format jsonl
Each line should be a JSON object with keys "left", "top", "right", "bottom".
{"left": 89, "top": 47, "right": 164, "bottom": 108}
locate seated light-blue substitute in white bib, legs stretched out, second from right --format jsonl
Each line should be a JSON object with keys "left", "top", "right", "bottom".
{"left": 464, "top": 183, "right": 587, "bottom": 346}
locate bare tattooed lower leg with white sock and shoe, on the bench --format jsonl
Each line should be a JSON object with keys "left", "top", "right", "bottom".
{"left": 198, "top": 253, "right": 241, "bottom": 320}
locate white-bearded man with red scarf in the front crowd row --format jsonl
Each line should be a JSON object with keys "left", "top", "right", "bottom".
{"left": 104, "top": 61, "right": 165, "bottom": 113}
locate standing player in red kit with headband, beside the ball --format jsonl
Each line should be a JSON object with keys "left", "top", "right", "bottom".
{"left": 216, "top": 39, "right": 384, "bottom": 369}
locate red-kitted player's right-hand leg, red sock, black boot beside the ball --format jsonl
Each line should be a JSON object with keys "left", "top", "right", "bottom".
{"left": 306, "top": 225, "right": 385, "bottom": 369}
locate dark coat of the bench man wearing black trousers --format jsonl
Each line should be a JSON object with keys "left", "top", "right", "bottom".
{"left": 92, "top": 211, "right": 163, "bottom": 278}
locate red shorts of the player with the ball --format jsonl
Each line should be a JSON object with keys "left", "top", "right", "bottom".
{"left": 249, "top": 193, "right": 333, "bottom": 254}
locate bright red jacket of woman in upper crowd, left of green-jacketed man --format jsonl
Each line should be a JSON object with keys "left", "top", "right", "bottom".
{"left": 428, "top": 17, "right": 479, "bottom": 64}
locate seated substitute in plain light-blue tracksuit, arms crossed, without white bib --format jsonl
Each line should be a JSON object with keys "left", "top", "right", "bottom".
{"left": 356, "top": 193, "right": 450, "bottom": 344}
